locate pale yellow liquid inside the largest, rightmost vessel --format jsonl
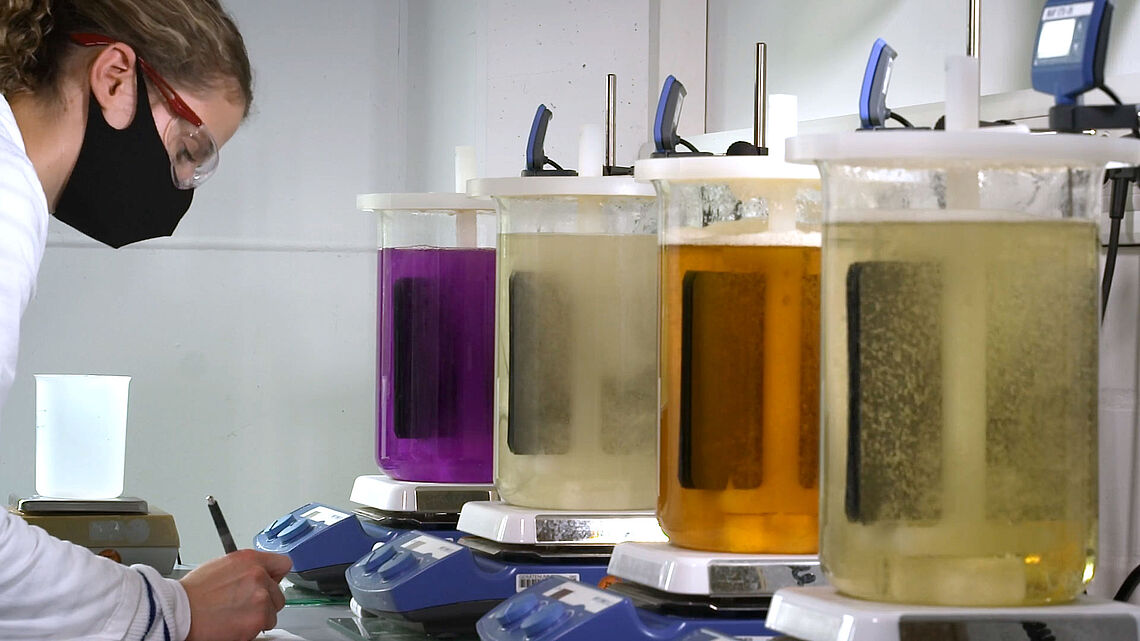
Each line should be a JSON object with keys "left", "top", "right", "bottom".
{"left": 821, "top": 212, "right": 1098, "bottom": 606}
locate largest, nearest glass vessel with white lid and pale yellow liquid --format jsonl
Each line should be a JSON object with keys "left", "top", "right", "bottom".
{"left": 788, "top": 130, "right": 1140, "bottom": 607}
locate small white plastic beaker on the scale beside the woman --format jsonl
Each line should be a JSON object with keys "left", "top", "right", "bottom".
{"left": 35, "top": 374, "right": 131, "bottom": 498}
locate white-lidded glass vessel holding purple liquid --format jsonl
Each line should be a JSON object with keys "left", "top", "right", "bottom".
{"left": 358, "top": 194, "right": 495, "bottom": 484}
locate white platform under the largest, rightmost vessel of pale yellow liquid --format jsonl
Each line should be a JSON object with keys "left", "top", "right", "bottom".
{"left": 767, "top": 586, "right": 1140, "bottom": 641}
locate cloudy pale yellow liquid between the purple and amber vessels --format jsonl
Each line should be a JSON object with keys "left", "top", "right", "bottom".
{"left": 495, "top": 234, "right": 657, "bottom": 510}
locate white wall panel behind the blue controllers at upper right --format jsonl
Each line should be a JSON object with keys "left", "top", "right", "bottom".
{"left": 708, "top": 0, "right": 1057, "bottom": 131}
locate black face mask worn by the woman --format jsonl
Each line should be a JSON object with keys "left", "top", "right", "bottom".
{"left": 55, "top": 70, "right": 194, "bottom": 249}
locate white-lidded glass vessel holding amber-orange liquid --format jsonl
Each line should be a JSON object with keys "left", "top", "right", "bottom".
{"left": 636, "top": 156, "right": 821, "bottom": 554}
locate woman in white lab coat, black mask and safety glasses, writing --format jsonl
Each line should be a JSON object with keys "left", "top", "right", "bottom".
{"left": 0, "top": 0, "right": 290, "bottom": 641}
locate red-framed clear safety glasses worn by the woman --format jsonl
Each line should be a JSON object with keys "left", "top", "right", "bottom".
{"left": 71, "top": 33, "right": 218, "bottom": 189}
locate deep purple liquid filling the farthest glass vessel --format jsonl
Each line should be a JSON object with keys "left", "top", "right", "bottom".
{"left": 376, "top": 248, "right": 495, "bottom": 484}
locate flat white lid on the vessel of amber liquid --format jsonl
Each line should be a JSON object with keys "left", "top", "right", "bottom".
{"left": 634, "top": 156, "right": 820, "bottom": 182}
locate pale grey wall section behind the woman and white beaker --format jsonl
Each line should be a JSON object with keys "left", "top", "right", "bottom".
{"left": 0, "top": 0, "right": 404, "bottom": 561}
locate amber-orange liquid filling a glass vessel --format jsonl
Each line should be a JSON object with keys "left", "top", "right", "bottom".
{"left": 658, "top": 233, "right": 820, "bottom": 553}
